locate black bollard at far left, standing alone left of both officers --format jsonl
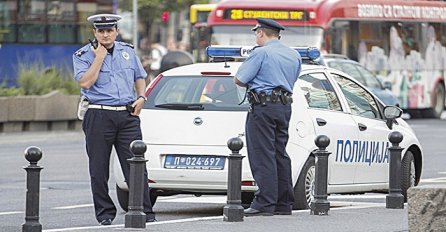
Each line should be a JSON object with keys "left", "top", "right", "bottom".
{"left": 22, "top": 146, "right": 43, "bottom": 232}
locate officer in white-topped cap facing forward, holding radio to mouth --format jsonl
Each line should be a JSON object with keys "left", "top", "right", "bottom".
{"left": 73, "top": 14, "right": 155, "bottom": 225}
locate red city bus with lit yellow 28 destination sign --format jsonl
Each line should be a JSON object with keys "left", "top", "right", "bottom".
{"left": 207, "top": 0, "right": 446, "bottom": 118}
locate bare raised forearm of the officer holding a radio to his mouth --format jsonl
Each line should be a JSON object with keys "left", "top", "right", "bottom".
{"left": 79, "top": 46, "right": 107, "bottom": 89}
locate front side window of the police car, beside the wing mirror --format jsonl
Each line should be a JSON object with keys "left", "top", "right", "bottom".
{"left": 332, "top": 73, "right": 380, "bottom": 118}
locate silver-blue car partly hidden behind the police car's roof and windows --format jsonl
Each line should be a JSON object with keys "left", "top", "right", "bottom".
{"left": 321, "top": 54, "right": 399, "bottom": 106}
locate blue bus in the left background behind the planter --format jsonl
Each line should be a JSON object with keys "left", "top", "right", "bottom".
{"left": 0, "top": 0, "right": 113, "bottom": 87}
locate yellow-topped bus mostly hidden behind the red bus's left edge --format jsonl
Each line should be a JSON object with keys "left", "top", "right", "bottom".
{"left": 189, "top": 4, "right": 216, "bottom": 62}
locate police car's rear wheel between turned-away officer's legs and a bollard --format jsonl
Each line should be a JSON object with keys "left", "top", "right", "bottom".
{"left": 293, "top": 156, "right": 316, "bottom": 210}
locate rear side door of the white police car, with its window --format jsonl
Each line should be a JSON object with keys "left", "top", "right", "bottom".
{"left": 293, "top": 69, "right": 358, "bottom": 184}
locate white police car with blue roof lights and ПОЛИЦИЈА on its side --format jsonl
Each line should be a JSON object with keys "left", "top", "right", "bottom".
{"left": 113, "top": 44, "right": 423, "bottom": 209}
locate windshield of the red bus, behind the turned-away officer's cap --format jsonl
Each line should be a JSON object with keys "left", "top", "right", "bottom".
{"left": 211, "top": 26, "right": 323, "bottom": 48}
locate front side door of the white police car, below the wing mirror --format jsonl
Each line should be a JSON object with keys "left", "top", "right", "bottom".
{"left": 331, "top": 73, "right": 390, "bottom": 184}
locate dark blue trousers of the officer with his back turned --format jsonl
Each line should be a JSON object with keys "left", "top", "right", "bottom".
{"left": 245, "top": 103, "right": 294, "bottom": 212}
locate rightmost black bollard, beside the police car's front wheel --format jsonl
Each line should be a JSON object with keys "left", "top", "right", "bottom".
{"left": 386, "top": 131, "right": 404, "bottom": 209}
